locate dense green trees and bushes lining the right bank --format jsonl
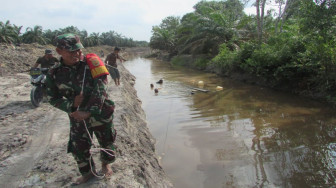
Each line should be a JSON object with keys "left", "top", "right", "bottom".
{"left": 149, "top": 0, "right": 336, "bottom": 101}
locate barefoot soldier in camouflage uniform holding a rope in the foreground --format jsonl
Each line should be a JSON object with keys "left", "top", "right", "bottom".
{"left": 47, "top": 34, "right": 116, "bottom": 184}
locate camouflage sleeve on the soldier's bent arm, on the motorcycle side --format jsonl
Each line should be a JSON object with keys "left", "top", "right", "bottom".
{"left": 46, "top": 74, "right": 73, "bottom": 113}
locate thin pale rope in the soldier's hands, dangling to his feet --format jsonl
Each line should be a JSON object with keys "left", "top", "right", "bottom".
{"left": 77, "top": 66, "right": 115, "bottom": 178}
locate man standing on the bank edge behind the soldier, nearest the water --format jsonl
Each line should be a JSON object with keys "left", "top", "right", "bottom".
{"left": 105, "top": 47, "right": 126, "bottom": 86}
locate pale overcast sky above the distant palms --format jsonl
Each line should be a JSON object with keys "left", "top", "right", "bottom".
{"left": 0, "top": 0, "right": 255, "bottom": 41}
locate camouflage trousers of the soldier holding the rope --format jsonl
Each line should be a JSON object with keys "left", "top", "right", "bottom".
{"left": 68, "top": 118, "right": 117, "bottom": 175}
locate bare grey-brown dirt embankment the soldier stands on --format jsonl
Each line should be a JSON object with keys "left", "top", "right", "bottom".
{"left": 0, "top": 45, "right": 172, "bottom": 188}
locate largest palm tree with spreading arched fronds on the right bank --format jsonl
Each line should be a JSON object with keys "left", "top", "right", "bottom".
{"left": 178, "top": 0, "right": 244, "bottom": 56}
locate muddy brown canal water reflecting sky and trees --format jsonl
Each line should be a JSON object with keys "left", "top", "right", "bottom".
{"left": 125, "top": 58, "right": 336, "bottom": 188}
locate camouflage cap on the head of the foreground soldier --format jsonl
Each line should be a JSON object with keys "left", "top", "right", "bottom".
{"left": 56, "top": 33, "right": 84, "bottom": 51}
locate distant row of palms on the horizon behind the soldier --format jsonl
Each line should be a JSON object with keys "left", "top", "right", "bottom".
{"left": 0, "top": 21, "right": 148, "bottom": 47}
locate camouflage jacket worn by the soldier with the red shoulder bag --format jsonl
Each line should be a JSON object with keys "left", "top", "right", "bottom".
{"left": 46, "top": 59, "right": 114, "bottom": 126}
